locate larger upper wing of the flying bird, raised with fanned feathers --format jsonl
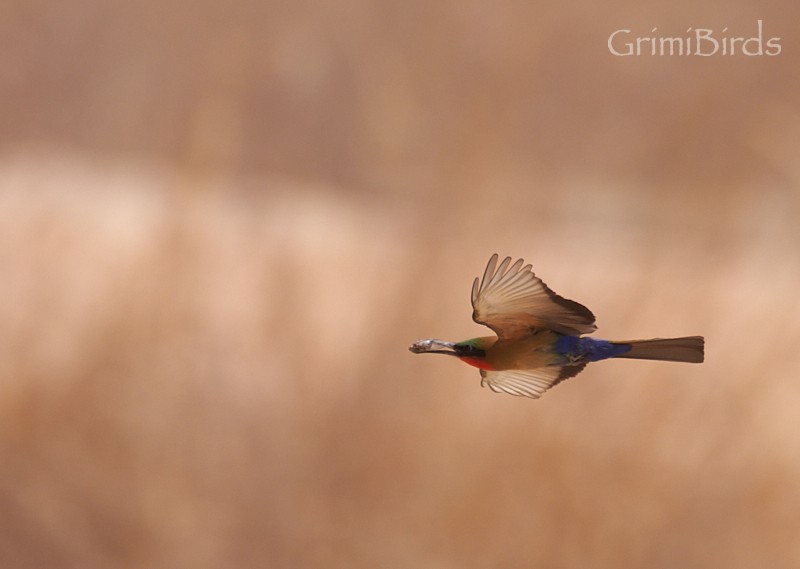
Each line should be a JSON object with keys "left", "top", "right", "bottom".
{"left": 472, "top": 253, "right": 597, "bottom": 339}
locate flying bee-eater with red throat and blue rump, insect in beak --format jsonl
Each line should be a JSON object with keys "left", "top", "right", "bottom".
{"left": 409, "top": 253, "right": 704, "bottom": 398}
